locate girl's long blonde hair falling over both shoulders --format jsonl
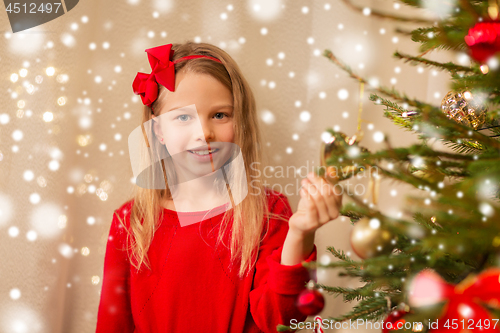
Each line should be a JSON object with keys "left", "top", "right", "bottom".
{"left": 119, "top": 41, "right": 284, "bottom": 278}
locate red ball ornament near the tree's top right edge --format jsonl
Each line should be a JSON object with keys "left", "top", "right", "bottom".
{"left": 465, "top": 21, "right": 500, "bottom": 63}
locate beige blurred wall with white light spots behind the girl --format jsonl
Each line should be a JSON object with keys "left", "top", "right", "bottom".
{"left": 0, "top": 0, "right": 466, "bottom": 333}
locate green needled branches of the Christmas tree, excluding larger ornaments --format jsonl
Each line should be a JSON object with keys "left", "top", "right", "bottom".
{"left": 309, "top": 0, "right": 500, "bottom": 330}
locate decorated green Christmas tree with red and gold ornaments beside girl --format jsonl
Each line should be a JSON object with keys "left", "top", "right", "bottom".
{"left": 278, "top": 0, "right": 500, "bottom": 332}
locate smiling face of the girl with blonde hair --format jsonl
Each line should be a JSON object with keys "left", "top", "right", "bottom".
{"left": 151, "top": 70, "right": 234, "bottom": 178}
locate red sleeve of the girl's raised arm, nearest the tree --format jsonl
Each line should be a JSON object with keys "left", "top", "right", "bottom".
{"left": 250, "top": 194, "right": 317, "bottom": 332}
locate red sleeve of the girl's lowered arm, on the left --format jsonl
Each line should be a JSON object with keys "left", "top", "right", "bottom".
{"left": 96, "top": 210, "right": 135, "bottom": 333}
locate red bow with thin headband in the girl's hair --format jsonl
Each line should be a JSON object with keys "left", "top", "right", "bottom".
{"left": 132, "top": 44, "right": 222, "bottom": 107}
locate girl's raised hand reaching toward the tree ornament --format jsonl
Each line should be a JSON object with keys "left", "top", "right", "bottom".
{"left": 289, "top": 172, "right": 342, "bottom": 235}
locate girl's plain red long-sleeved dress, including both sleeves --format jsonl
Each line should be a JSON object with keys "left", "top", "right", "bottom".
{"left": 96, "top": 191, "right": 317, "bottom": 333}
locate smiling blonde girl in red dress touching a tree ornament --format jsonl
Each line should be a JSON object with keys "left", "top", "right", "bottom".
{"left": 96, "top": 42, "right": 342, "bottom": 333}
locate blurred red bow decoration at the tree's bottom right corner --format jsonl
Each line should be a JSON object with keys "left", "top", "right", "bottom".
{"left": 409, "top": 268, "right": 500, "bottom": 333}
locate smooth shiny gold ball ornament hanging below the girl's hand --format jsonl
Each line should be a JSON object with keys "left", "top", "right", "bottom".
{"left": 351, "top": 217, "right": 394, "bottom": 259}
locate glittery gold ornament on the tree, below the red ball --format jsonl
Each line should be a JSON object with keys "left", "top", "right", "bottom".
{"left": 441, "top": 90, "right": 486, "bottom": 130}
